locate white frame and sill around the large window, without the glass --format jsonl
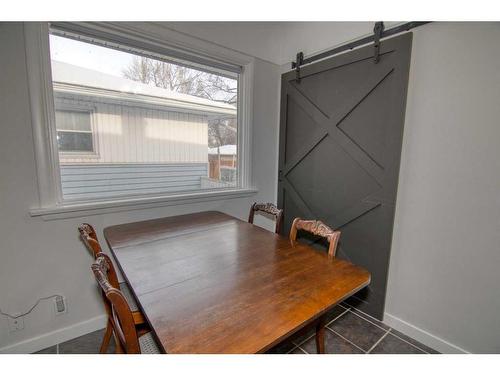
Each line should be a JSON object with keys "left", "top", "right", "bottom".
{"left": 24, "top": 23, "right": 257, "bottom": 220}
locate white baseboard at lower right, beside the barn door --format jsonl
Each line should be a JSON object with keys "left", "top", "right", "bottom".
{"left": 384, "top": 313, "right": 469, "bottom": 354}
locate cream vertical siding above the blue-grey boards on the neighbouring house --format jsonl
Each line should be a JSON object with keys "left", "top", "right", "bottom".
{"left": 55, "top": 92, "right": 208, "bottom": 164}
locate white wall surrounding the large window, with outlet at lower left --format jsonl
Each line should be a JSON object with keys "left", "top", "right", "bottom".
{"left": 0, "top": 23, "right": 279, "bottom": 352}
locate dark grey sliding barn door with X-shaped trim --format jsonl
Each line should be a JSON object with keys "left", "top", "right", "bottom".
{"left": 278, "top": 33, "right": 412, "bottom": 319}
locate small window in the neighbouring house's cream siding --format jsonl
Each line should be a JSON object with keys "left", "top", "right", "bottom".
{"left": 56, "top": 110, "right": 94, "bottom": 154}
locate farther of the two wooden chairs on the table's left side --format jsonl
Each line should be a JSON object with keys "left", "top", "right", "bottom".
{"left": 78, "top": 223, "right": 146, "bottom": 353}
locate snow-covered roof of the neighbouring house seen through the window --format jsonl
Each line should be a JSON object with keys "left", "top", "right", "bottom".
{"left": 52, "top": 60, "right": 236, "bottom": 115}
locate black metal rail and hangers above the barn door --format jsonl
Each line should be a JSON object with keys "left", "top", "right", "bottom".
{"left": 292, "top": 21, "right": 429, "bottom": 71}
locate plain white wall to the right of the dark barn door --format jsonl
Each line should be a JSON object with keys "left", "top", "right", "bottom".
{"left": 386, "top": 23, "right": 500, "bottom": 353}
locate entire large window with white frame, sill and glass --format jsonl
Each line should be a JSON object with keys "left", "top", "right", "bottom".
{"left": 24, "top": 22, "right": 257, "bottom": 220}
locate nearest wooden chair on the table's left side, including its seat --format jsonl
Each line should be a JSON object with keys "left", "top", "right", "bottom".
{"left": 92, "top": 253, "right": 160, "bottom": 354}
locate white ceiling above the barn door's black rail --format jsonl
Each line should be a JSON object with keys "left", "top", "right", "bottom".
{"left": 161, "top": 22, "right": 400, "bottom": 65}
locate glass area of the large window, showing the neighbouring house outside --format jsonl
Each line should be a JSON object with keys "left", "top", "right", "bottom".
{"left": 27, "top": 24, "right": 249, "bottom": 207}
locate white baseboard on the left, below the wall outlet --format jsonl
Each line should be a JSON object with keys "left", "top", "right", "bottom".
{"left": 0, "top": 315, "right": 107, "bottom": 354}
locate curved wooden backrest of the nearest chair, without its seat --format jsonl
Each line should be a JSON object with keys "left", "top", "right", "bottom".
{"left": 92, "top": 253, "right": 141, "bottom": 354}
